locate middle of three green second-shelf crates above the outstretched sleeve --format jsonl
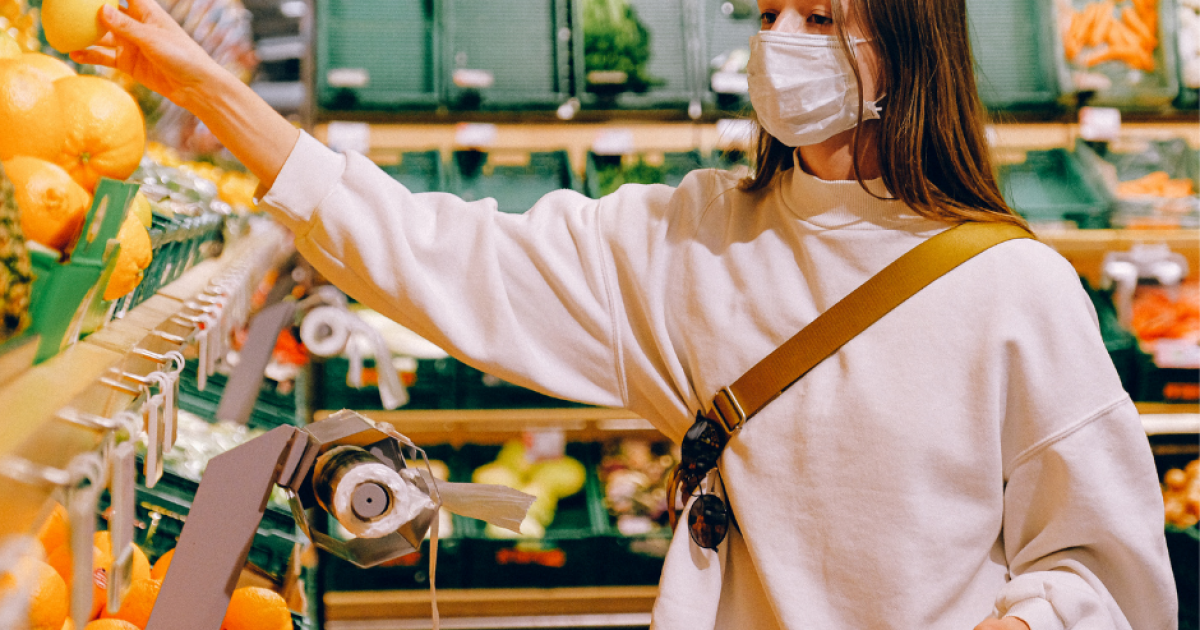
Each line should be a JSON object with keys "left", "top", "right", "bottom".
{"left": 449, "top": 151, "right": 578, "bottom": 214}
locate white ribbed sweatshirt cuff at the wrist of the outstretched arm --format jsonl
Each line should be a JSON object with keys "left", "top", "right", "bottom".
{"left": 262, "top": 131, "right": 346, "bottom": 235}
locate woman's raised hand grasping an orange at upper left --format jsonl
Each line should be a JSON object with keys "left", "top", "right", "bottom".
{"left": 71, "top": 0, "right": 224, "bottom": 109}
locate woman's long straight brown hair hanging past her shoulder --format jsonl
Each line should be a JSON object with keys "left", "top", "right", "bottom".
{"left": 739, "top": 0, "right": 1028, "bottom": 227}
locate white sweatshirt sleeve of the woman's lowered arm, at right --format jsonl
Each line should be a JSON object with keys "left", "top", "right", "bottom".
{"left": 995, "top": 242, "right": 1178, "bottom": 630}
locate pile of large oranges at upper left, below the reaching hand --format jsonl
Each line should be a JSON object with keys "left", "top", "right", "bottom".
{"left": 0, "top": 47, "right": 150, "bottom": 300}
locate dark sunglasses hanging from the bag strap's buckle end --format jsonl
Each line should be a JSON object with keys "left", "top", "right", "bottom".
{"left": 667, "top": 413, "right": 730, "bottom": 550}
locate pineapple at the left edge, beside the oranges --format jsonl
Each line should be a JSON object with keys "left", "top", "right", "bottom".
{"left": 0, "top": 159, "right": 34, "bottom": 343}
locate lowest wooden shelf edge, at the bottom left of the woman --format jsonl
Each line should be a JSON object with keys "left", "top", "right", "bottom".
{"left": 324, "top": 586, "right": 658, "bottom": 630}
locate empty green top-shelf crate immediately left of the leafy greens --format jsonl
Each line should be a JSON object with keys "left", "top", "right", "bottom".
{"left": 443, "top": 0, "right": 571, "bottom": 109}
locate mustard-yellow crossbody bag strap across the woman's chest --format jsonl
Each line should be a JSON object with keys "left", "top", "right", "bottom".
{"left": 710, "top": 222, "right": 1034, "bottom": 433}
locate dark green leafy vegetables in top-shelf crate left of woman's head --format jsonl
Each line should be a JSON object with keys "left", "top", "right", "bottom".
{"left": 583, "top": 0, "right": 661, "bottom": 92}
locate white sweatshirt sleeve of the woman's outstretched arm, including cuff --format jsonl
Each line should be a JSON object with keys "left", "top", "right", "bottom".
{"left": 263, "top": 133, "right": 638, "bottom": 407}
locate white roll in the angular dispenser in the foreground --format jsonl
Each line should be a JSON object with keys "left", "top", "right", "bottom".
{"left": 334, "top": 463, "right": 436, "bottom": 538}
